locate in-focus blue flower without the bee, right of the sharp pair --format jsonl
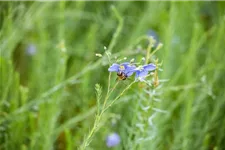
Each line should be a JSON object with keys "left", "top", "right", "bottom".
{"left": 135, "top": 64, "right": 156, "bottom": 81}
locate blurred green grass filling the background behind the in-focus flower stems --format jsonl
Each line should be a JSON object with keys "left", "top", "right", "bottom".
{"left": 0, "top": 1, "right": 225, "bottom": 150}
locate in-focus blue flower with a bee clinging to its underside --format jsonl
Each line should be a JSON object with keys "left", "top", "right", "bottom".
{"left": 108, "top": 62, "right": 136, "bottom": 77}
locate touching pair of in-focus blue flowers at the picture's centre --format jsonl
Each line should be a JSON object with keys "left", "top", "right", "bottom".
{"left": 108, "top": 62, "right": 156, "bottom": 81}
